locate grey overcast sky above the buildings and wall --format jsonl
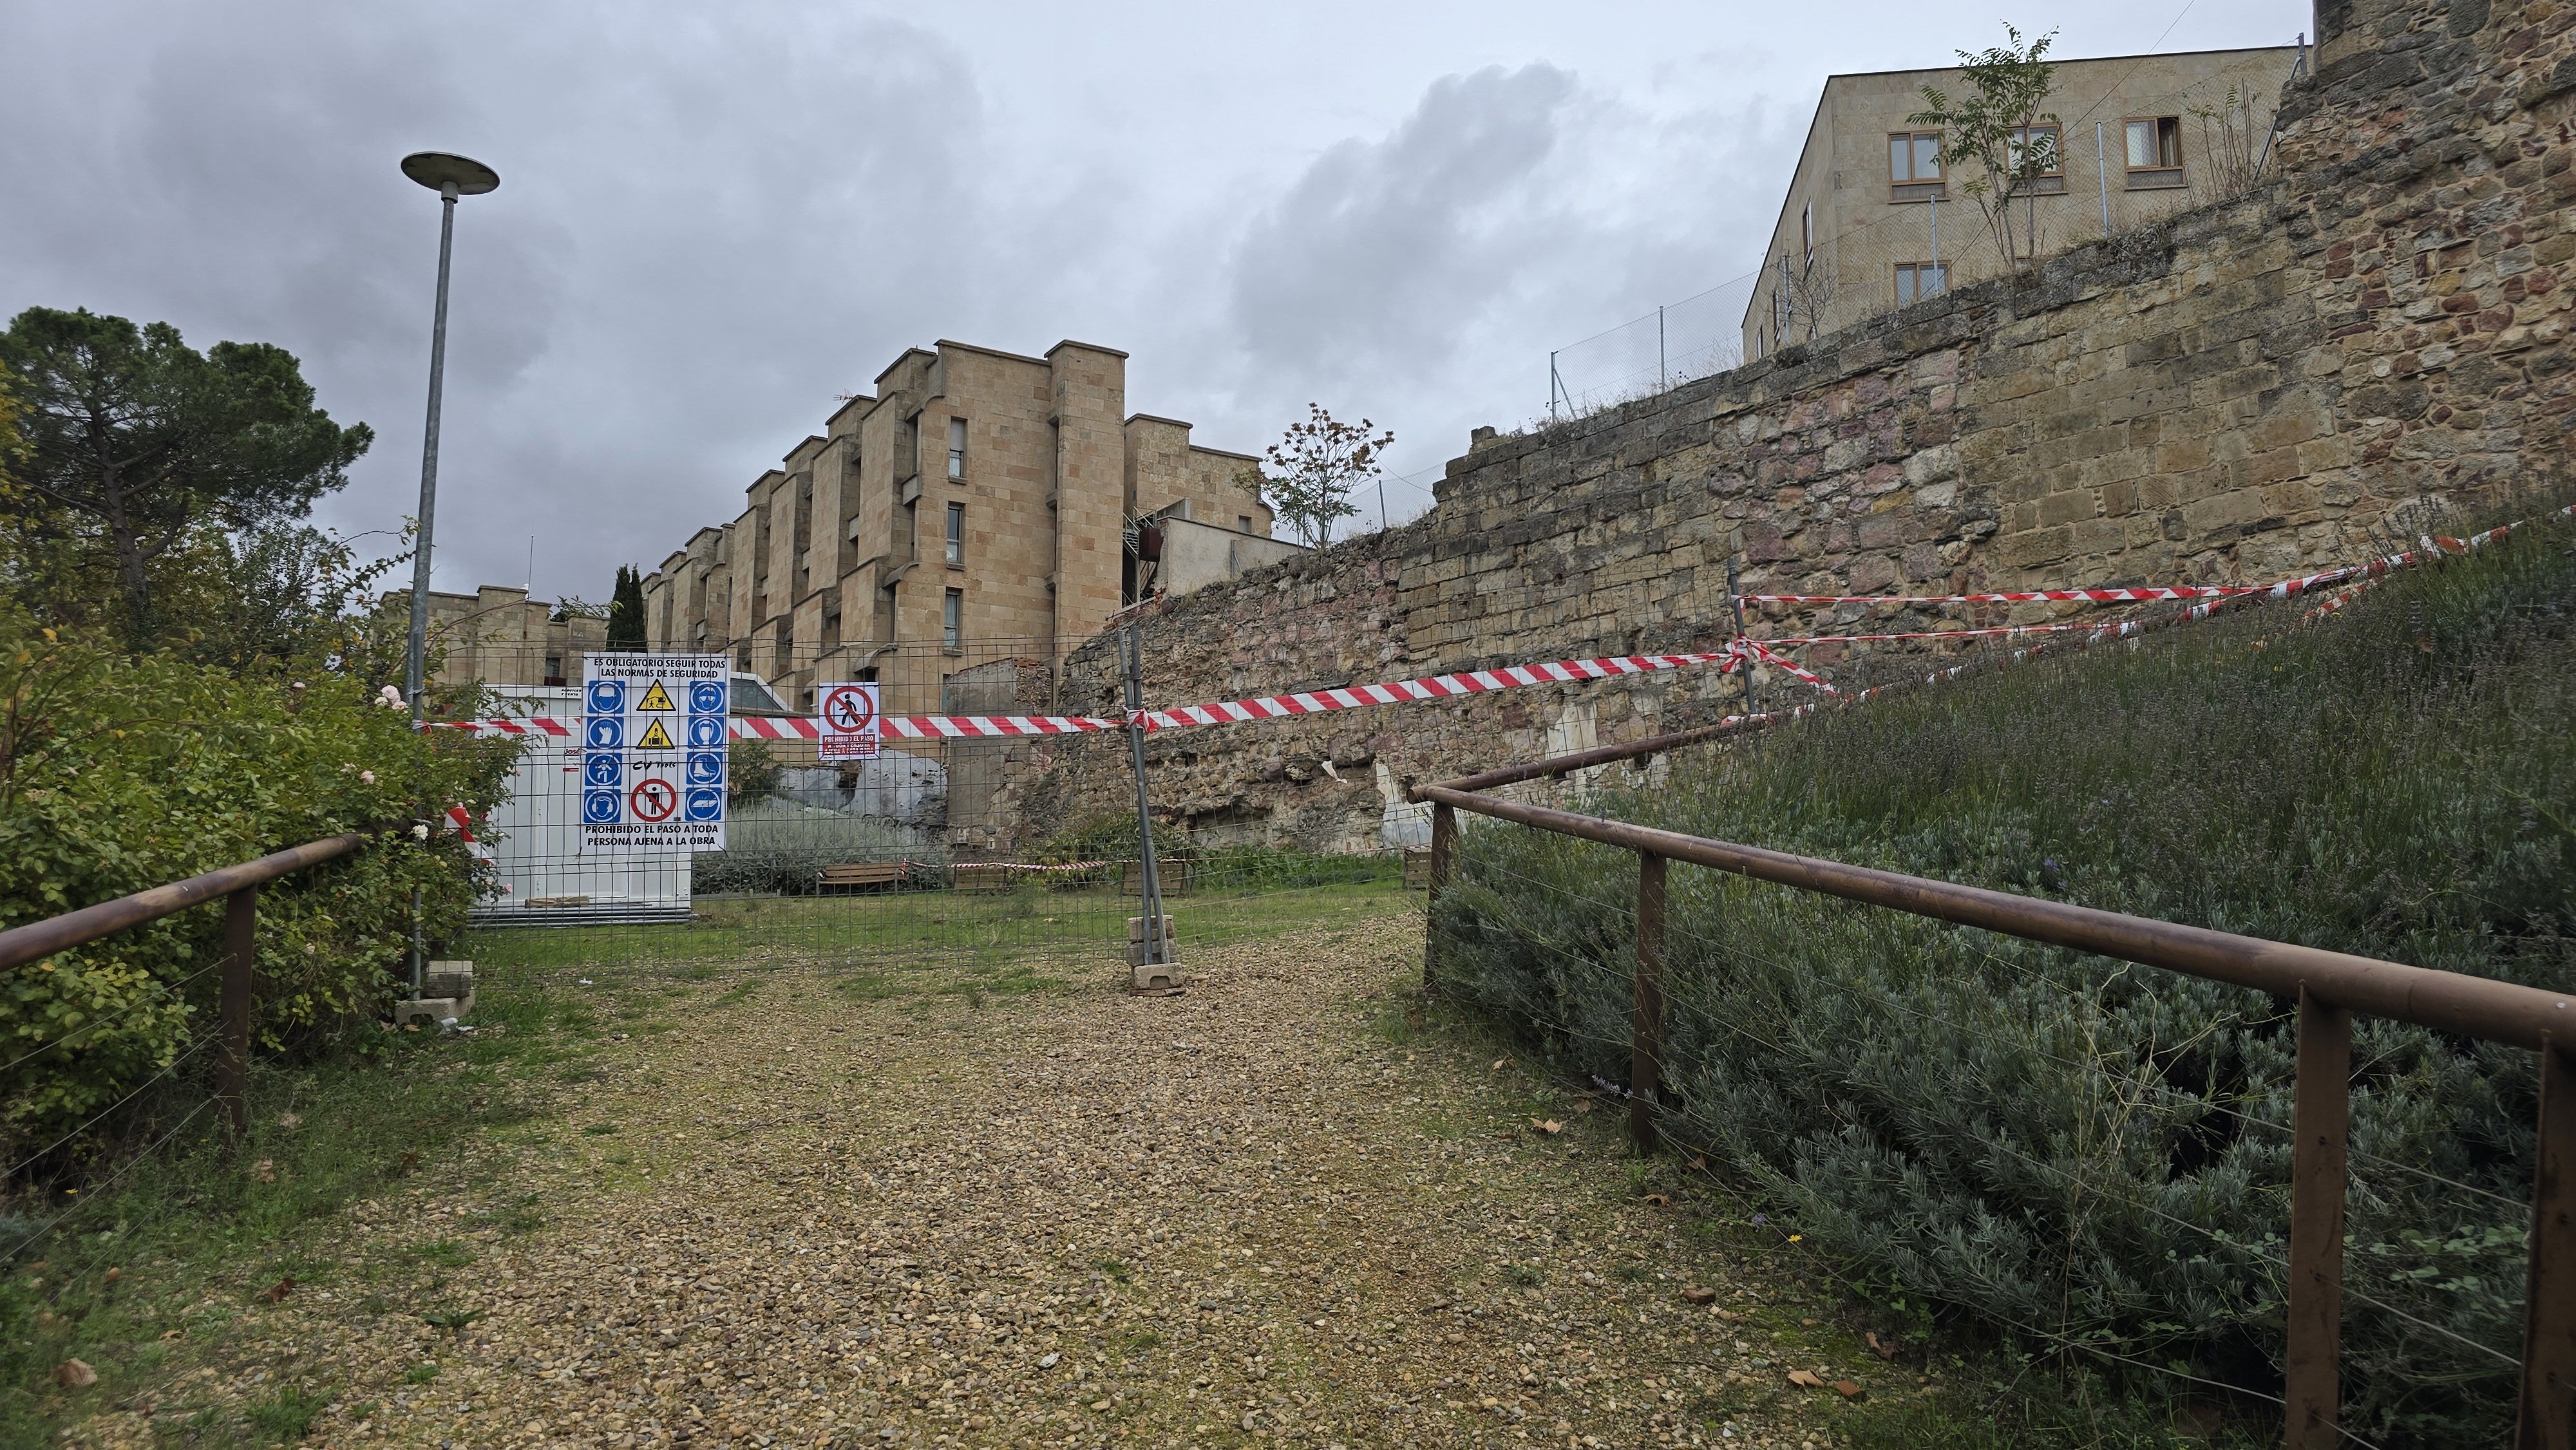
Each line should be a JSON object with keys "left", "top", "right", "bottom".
{"left": 0, "top": 0, "right": 2311, "bottom": 600}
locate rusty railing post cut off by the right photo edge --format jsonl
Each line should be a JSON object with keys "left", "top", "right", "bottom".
{"left": 2514, "top": 1038, "right": 2576, "bottom": 1450}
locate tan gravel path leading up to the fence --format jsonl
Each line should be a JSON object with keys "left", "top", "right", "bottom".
{"left": 85, "top": 914, "right": 1911, "bottom": 1450}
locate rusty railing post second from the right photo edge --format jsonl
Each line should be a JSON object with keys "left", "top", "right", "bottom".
{"left": 2282, "top": 986, "right": 2352, "bottom": 1450}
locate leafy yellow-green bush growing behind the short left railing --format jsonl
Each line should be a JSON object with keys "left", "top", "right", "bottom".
{"left": 0, "top": 610, "right": 518, "bottom": 1167}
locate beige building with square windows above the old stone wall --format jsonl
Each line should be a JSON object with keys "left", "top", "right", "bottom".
{"left": 1744, "top": 46, "right": 2306, "bottom": 361}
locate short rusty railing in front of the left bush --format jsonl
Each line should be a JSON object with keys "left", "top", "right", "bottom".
{"left": 0, "top": 834, "right": 366, "bottom": 1141}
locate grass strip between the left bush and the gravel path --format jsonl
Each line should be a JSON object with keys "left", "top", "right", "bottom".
{"left": 0, "top": 976, "right": 590, "bottom": 1450}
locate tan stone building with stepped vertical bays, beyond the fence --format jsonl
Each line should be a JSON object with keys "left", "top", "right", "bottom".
{"left": 644, "top": 340, "right": 1270, "bottom": 708}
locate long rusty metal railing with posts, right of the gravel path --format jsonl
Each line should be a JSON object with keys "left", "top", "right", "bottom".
{"left": 1409, "top": 767, "right": 2576, "bottom": 1450}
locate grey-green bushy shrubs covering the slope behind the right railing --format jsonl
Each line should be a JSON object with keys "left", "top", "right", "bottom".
{"left": 1435, "top": 515, "right": 2576, "bottom": 1445}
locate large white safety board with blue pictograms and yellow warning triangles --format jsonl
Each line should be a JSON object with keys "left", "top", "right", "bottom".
{"left": 582, "top": 654, "right": 732, "bottom": 850}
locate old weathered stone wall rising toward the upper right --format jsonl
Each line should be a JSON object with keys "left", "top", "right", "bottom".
{"left": 997, "top": 0, "right": 2576, "bottom": 850}
